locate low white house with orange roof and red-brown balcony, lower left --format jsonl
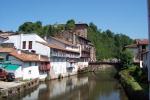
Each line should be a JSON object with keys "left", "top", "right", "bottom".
{"left": 0, "top": 48, "right": 50, "bottom": 80}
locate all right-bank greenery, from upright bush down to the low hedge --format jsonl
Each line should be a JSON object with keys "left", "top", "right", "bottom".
{"left": 119, "top": 50, "right": 149, "bottom": 100}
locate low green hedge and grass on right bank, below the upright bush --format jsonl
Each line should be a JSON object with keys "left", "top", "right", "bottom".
{"left": 119, "top": 65, "right": 149, "bottom": 100}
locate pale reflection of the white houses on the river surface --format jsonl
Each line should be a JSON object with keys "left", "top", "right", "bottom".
{"left": 23, "top": 76, "right": 88, "bottom": 100}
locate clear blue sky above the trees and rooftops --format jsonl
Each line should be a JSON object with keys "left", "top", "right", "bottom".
{"left": 0, "top": 0, "right": 148, "bottom": 39}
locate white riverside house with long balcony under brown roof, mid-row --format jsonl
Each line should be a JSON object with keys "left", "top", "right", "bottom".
{"left": 36, "top": 42, "right": 80, "bottom": 79}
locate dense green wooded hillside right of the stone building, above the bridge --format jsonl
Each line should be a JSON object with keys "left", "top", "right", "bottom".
{"left": 88, "top": 23, "right": 133, "bottom": 60}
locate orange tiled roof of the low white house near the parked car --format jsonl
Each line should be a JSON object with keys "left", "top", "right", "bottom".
{"left": 9, "top": 51, "right": 49, "bottom": 62}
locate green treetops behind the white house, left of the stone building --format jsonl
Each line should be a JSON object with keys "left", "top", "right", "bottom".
{"left": 18, "top": 21, "right": 65, "bottom": 37}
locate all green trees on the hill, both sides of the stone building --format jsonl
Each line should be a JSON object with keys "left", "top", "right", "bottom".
{"left": 18, "top": 20, "right": 133, "bottom": 60}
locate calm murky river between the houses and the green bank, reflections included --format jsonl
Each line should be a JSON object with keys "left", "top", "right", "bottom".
{"left": 11, "top": 67, "right": 128, "bottom": 100}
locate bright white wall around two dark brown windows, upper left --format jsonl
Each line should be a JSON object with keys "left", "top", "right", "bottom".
{"left": 4, "top": 34, "right": 50, "bottom": 56}
